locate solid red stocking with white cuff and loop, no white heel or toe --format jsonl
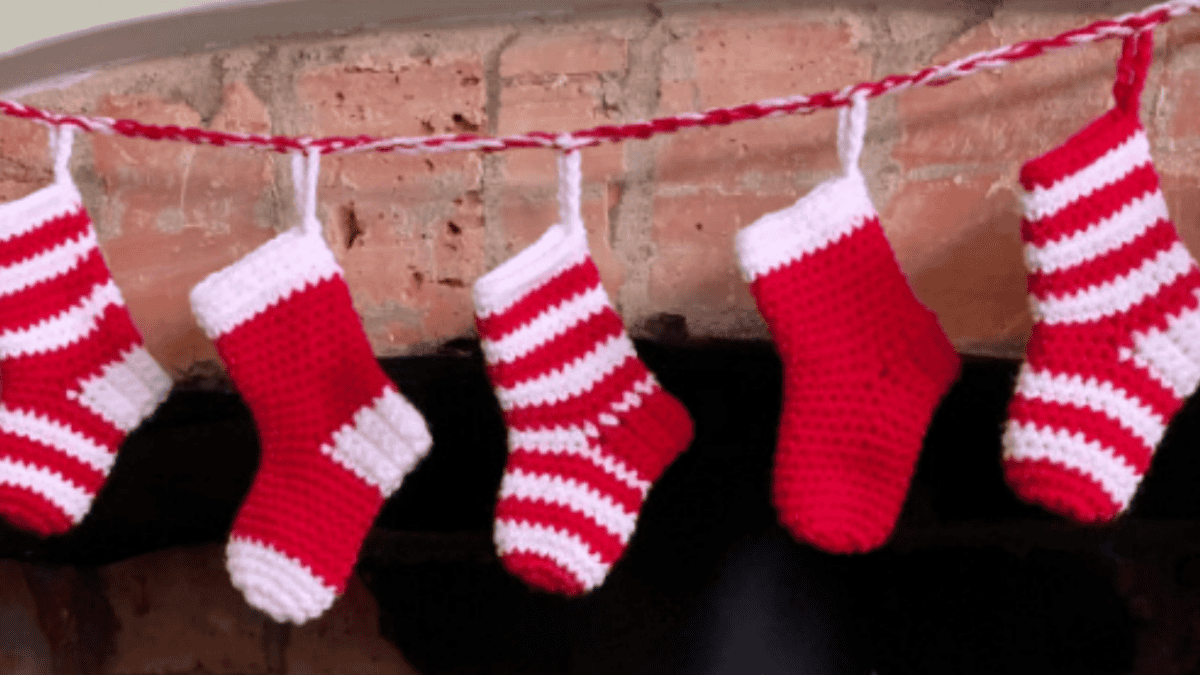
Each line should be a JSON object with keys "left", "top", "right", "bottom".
{"left": 737, "top": 98, "right": 959, "bottom": 552}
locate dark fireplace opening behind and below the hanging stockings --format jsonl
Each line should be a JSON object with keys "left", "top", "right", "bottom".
{"left": 0, "top": 341, "right": 1200, "bottom": 675}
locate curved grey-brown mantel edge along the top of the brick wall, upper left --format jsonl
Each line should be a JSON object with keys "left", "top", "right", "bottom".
{"left": 0, "top": 0, "right": 1147, "bottom": 97}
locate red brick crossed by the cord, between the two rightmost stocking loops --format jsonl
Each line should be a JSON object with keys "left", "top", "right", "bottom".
{"left": 892, "top": 12, "right": 1120, "bottom": 171}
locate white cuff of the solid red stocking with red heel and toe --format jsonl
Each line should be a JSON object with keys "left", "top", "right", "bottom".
{"left": 736, "top": 171, "right": 876, "bottom": 282}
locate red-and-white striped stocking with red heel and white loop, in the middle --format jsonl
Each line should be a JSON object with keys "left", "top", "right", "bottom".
{"left": 474, "top": 153, "right": 692, "bottom": 595}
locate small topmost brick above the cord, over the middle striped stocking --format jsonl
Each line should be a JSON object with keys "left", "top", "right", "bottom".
{"left": 500, "top": 28, "right": 625, "bottom": 78}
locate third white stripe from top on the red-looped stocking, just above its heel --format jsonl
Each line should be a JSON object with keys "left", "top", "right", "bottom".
{"left": 1030, "top": 241, "right": 1195, "bottom": 324}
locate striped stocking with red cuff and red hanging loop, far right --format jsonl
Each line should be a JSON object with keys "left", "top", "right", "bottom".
{"left": 1004, "top": 31, "right": 1200, "bottom": 522}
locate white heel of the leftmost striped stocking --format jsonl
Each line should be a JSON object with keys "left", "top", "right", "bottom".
{"left": 67, "top": 345, "right": 170, "bottom": 434}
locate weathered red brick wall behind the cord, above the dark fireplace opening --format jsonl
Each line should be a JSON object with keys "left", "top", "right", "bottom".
{"left": 0, "top": 2, "right": 1200, "bottom": 372}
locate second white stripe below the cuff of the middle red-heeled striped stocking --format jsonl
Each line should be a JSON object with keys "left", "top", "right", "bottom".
{"left": 496, "top": 331, "right": 637, "bottom": 411}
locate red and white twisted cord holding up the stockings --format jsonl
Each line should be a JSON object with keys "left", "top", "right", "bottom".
{"left": 0, "top": 0, "right": 1200, "bottom": 155}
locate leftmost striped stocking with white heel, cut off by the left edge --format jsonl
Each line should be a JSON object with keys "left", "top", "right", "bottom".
{"left": 0, "top": 130, "right": 170, "bottom": 536}
